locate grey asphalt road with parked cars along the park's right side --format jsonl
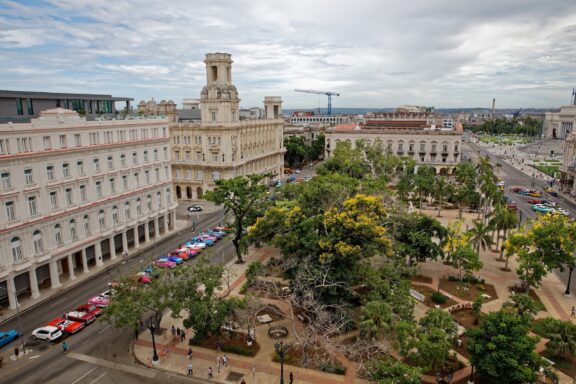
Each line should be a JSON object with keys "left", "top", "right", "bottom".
{"left": 464, "top": 142, "right": 576, "bottom": 294}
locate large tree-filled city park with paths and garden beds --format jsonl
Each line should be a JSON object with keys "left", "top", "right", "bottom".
{"left": 105, "top": 136, "right": 576, "bottom": 384}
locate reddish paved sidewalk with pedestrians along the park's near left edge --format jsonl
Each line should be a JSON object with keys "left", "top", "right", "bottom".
{"left": 133, "top": 247, "right": 367, "bottom": 384}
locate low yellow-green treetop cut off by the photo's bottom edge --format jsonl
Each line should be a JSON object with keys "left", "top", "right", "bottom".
{"left": 365, "top": 358, "right": 422, "bottom": 384}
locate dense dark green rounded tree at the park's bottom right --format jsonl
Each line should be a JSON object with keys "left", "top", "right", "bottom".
{"left": 467, "top": 311, "right": 541, "bottom": 384}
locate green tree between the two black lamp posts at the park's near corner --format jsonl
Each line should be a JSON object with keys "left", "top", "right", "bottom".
{"left": 170, "top": 258, "right": 243, "bottom": 340}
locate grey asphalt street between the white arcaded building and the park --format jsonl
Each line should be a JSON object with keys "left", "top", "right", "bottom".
{"left": 0, "top": 209, "right": 234, "bottom": 384}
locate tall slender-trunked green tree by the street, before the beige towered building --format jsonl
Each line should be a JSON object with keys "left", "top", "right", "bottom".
{"left": 204, "top": 174, "right": 271, "bottom": 263}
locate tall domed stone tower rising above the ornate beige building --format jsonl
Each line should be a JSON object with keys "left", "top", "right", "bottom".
{"left": 200, "top": 53, "right": 240, "bottom": 126}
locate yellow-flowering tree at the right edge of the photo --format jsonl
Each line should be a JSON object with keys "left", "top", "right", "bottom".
{"left": 504, "top": 213, "right": 576, "bottom": 292}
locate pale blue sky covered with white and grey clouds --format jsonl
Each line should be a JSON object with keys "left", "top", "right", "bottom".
{"left": 0, "top": 0, "right": 576, "bottom": 108}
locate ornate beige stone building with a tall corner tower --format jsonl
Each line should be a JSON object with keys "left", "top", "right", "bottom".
{"left": 168, "top": 53, "right": 285, "bottom": 199}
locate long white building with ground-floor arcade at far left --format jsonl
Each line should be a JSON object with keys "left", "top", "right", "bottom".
{"left": 0, "top": 108, "right": 176, "bottom": 308}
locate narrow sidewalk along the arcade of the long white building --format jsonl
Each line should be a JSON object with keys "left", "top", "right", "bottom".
{"left": 0, "top": 220, "right": 188, "bottom": 324}
